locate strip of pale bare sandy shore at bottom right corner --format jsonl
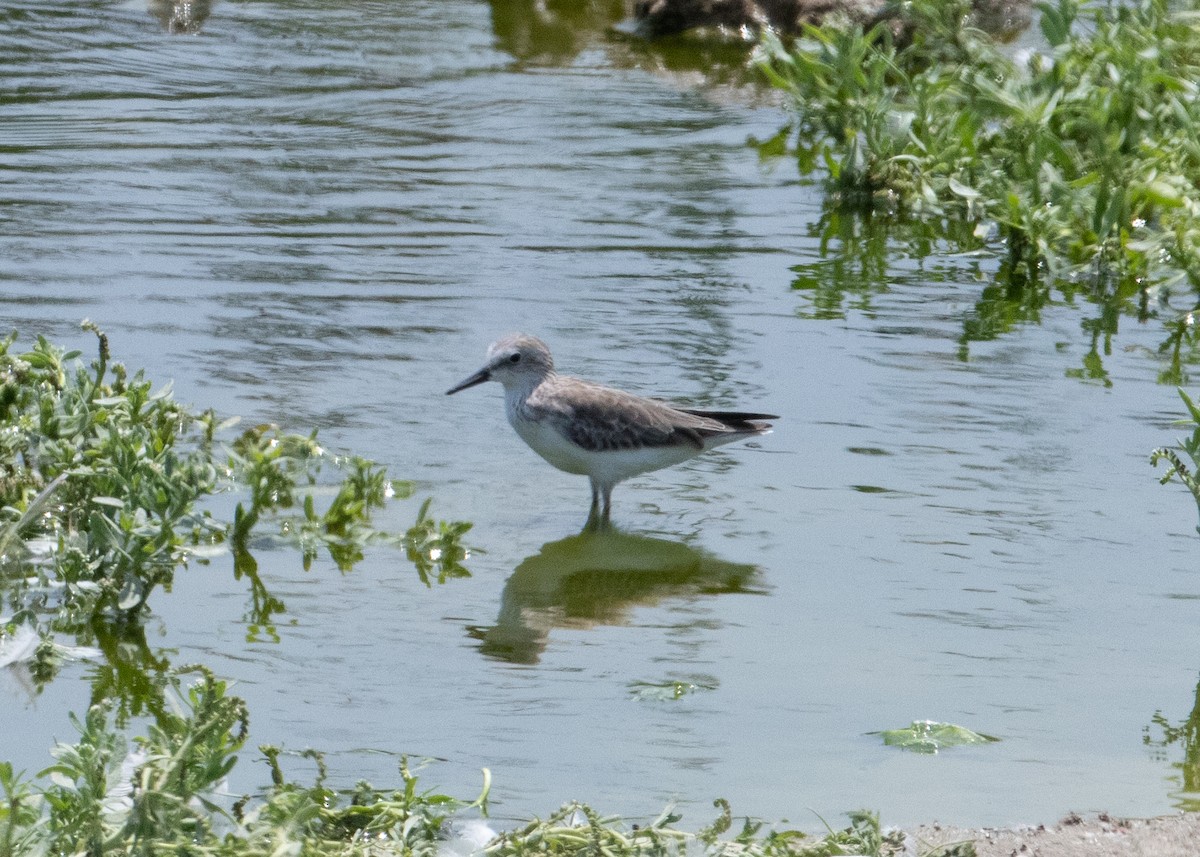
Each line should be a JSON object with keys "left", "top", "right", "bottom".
{"left": 910, "top": 813, "right": 1200, "bottom": 857}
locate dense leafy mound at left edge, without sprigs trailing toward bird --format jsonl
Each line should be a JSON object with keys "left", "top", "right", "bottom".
{"left": 0, "top": 331, "right": 221, "bottom": 621}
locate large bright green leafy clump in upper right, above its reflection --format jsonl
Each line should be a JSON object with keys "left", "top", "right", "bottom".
{"left": 758, "top": 0, "right": 1200, "bottom": 290}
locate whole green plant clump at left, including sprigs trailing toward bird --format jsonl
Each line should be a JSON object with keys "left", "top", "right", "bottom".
{"left": 0, "top": 323, "right": 469, "bottom": 691}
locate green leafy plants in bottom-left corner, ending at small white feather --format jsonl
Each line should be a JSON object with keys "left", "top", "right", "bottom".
{"left": 0, "top": 666, "right": 490, "bottom": 857}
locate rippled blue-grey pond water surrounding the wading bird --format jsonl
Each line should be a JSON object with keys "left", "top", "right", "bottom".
{"left": 0, "top": 0, "right": 1200, "bottom": 828}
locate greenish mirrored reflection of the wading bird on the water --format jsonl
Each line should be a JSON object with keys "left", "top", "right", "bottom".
{"left": 469, "top": 529, "right": 766, "bottom": 664}
